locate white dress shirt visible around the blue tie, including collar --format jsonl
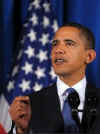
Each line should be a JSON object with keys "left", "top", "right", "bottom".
{"left": 57, "top": 77, "right": 86, "bottom": 121}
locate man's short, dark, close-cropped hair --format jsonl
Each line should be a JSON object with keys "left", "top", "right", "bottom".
{"left": 62, "top": 22, "right": 95, "bottom": 49}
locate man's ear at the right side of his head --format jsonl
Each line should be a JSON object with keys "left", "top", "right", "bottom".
{"left": 86, "top": 49, "right": 96, "bottom": 64}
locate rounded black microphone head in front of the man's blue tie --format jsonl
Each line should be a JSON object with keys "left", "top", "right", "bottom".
{"left": 68, "top": 91, "right": 80, "bottom": 109}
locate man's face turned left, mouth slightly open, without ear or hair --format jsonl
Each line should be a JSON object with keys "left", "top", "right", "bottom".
{"left": 51, "top": 27, "right": 87, "bottom": 76}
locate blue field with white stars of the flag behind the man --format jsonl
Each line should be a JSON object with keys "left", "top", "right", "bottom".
{"left": 5, "top": 0, "right": 58, "bottom": 103}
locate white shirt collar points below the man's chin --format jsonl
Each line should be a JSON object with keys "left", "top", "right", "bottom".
{"left": 57, "top": 77, "right": 86, "bottom": 101}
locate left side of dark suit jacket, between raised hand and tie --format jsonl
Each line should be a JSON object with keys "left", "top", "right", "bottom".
{"left": 31, "top": 85, "right": 64, "bottom": 133}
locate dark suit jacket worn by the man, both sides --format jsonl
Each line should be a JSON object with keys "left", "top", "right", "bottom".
{"left": 8, "top": 84, "right": 100, "bottom": 134}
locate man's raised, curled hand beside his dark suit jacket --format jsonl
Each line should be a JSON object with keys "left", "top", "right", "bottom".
{"left": 9, "top": 96, "right": 31, "bottom": 134}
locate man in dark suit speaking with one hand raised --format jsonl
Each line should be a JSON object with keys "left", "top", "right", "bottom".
{"left": 9, "top": 23, "right": 100, "bottom": 134}
